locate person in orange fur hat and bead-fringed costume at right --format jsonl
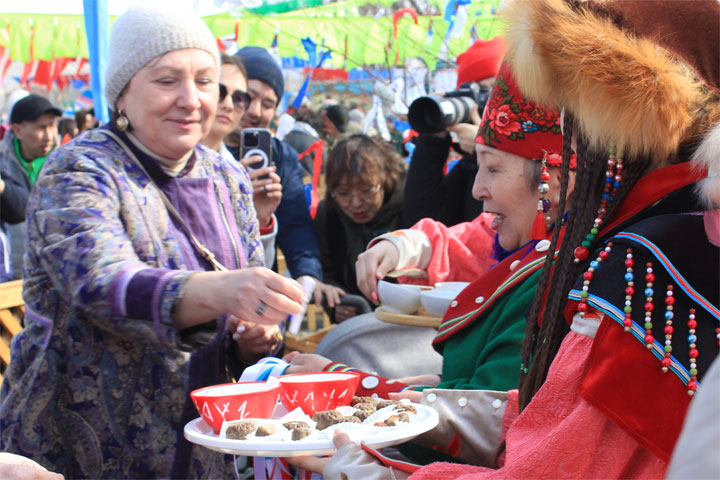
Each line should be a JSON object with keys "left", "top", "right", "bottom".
{"left": 288, "top": 0, "right": 720, "bottom": 479}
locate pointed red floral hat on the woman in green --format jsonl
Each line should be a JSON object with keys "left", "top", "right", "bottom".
{"left": 475, "top": 63, "right": 576, "bottom": 168}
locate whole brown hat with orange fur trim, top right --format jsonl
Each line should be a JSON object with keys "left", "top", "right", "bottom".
{"left": 502, "top": 0, "right": 720, "bottom": 208}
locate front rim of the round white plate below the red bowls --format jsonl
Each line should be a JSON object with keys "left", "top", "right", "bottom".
{"left": 185, "top": 403, "right": 438, "bottom": 457}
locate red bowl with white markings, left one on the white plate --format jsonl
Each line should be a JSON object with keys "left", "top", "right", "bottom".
{"left": 190, "top": 382, "right": 280, "bottom": 435}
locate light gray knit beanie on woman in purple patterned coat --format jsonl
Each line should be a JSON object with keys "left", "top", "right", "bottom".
{"left": 105, "top": 5, "right": 220, "bottom": 110}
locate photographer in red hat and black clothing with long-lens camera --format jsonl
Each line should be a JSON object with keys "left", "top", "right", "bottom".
{"left": 403, "top": 37, "right": 505, "bottom": 226}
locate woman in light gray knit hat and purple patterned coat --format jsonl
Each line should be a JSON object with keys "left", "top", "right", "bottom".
{"left": 0, "top": 6, "right": 306, "bottom": 478}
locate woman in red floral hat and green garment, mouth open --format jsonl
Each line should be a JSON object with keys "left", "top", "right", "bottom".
{"left": 288, "top": 64, "right": 572, "bottom": 462}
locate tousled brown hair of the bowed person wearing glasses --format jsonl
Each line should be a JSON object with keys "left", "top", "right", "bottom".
{"left": 325, "top": 134, "right": 404, "bottom": 205}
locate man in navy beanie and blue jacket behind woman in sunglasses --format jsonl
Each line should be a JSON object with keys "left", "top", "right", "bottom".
{"left": 225, "top": 47, "right": 334, "bottom": 300}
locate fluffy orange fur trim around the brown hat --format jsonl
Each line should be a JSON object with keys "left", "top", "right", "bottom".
{"left": 504, "top": 0, "right": 720, "bottom": 167}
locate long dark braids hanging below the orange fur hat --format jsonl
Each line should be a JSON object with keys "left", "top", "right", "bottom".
{"left": 519, "top": 119, "right": 649, "bottom": 409}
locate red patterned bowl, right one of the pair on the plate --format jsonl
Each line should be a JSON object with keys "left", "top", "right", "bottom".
{"left": 278, "top": 372, "right": 360, "bottom": 416}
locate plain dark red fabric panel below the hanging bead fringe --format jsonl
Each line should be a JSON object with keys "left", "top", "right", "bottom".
{"left": 578, "top": 319, "right": 690, "bottom": 462}
